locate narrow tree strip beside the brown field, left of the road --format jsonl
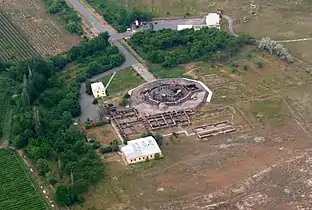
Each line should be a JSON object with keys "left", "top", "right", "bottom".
{"left": 43, "top": 0, "right": 83, "bottom": 35}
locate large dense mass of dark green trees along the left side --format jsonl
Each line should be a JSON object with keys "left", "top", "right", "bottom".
{"left": 0, "top": 33, "right": 125, "bottom": 205}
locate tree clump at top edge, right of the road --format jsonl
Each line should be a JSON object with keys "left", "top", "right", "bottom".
{"left": 87, "top": 0, "right": 152, "bottom": 32}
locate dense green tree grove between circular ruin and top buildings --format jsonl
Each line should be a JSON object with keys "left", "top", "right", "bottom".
{"left": 129, "top": 28, "right": 252, "bottom": 68}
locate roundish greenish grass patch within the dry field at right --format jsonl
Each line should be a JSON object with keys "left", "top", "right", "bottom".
{"left": 251, "top": 100, "right": 287, "bottom": 125}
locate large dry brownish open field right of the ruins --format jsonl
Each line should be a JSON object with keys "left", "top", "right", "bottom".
{"left": 74, "top": 51, "right": 312, "bottom": 210}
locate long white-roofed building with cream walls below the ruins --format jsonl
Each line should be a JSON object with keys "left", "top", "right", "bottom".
{"left": 120, "top": 136, "right": 162, "bottom": 164}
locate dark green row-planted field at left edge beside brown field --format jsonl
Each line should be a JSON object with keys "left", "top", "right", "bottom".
{"left": 0, "top": 12, "right": 39, "bottom": 61}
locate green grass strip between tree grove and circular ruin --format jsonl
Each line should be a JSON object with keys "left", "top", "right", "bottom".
{"left": 148, "top": 65, "right": 192, "bottom": 79}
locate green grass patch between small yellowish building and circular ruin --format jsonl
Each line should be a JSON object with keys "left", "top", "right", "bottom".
{"left": 100, "top": 67, "right": 144, "bottom": 95}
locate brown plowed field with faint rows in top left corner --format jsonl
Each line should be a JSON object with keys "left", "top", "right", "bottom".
{"left": 0, "top": 0, "right": 80, "bottom": 57}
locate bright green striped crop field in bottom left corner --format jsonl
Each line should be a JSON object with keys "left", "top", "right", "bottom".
{"left": 0, "top": 149, "right": 48, "bottom": 210}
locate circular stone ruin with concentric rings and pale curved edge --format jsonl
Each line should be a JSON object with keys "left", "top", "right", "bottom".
{"left": 130, "top": 78, "right": 212, "bottom": 115}
